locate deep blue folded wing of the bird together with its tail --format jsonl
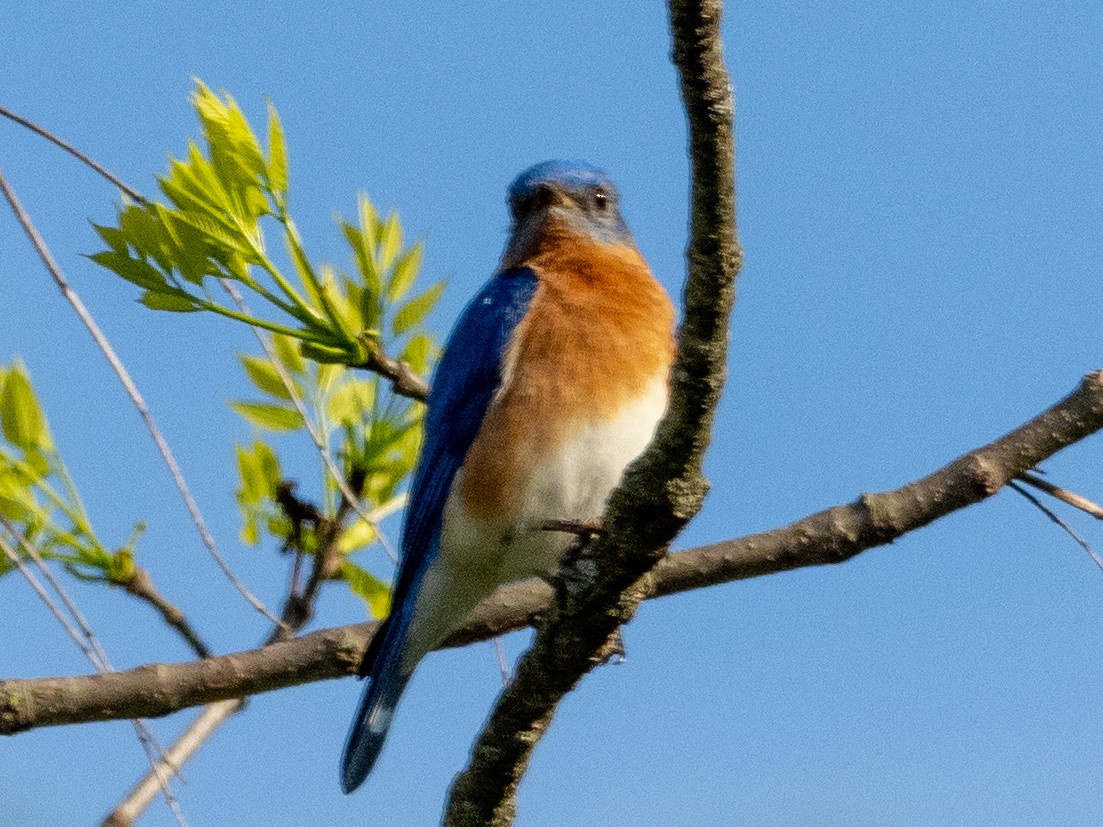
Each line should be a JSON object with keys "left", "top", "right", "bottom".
{"left": 341, "top": 268, "right": 537, "bottom": 793}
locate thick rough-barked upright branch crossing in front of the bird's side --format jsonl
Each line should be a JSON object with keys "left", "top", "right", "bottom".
{"left": 445, "top": 0, "right": 742, "bottom": 827}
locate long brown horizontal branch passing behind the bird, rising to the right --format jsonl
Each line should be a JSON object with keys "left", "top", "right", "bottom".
{"left": 0, "top": 370, "right": 1103, "bottom": 735}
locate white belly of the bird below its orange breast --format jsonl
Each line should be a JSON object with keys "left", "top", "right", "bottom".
{"left": 407, "top": 382, "right": 666, "bottom": 668}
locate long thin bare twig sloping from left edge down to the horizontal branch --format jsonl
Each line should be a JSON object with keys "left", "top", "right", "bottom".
{"left": 0, "top": 171, "right": 279, "bottom": 623}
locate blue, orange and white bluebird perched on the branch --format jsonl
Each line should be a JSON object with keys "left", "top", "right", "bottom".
{"left": 341, "top": 161, "right": 675, "bottom": 793}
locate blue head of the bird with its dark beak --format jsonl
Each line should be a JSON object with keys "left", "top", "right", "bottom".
{"left": 506, "top": 161, "right": 635, "bottom": 257}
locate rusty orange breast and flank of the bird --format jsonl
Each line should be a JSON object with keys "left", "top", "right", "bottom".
{"left": 460, "top": 220, "right": 674, "bottom": 519}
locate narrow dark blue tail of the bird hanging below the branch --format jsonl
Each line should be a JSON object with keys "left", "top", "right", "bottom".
{"left": 341, "top": 617, "right": 410, "bottom": 793}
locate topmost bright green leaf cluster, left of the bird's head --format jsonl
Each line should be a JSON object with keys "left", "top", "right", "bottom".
{"left": 92, "top": 80, "right": 443, "bottom": 370}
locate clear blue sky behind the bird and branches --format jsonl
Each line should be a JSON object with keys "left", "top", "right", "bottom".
{"left": 0, "top": 0, "right": 1103, "bottom": 827}
